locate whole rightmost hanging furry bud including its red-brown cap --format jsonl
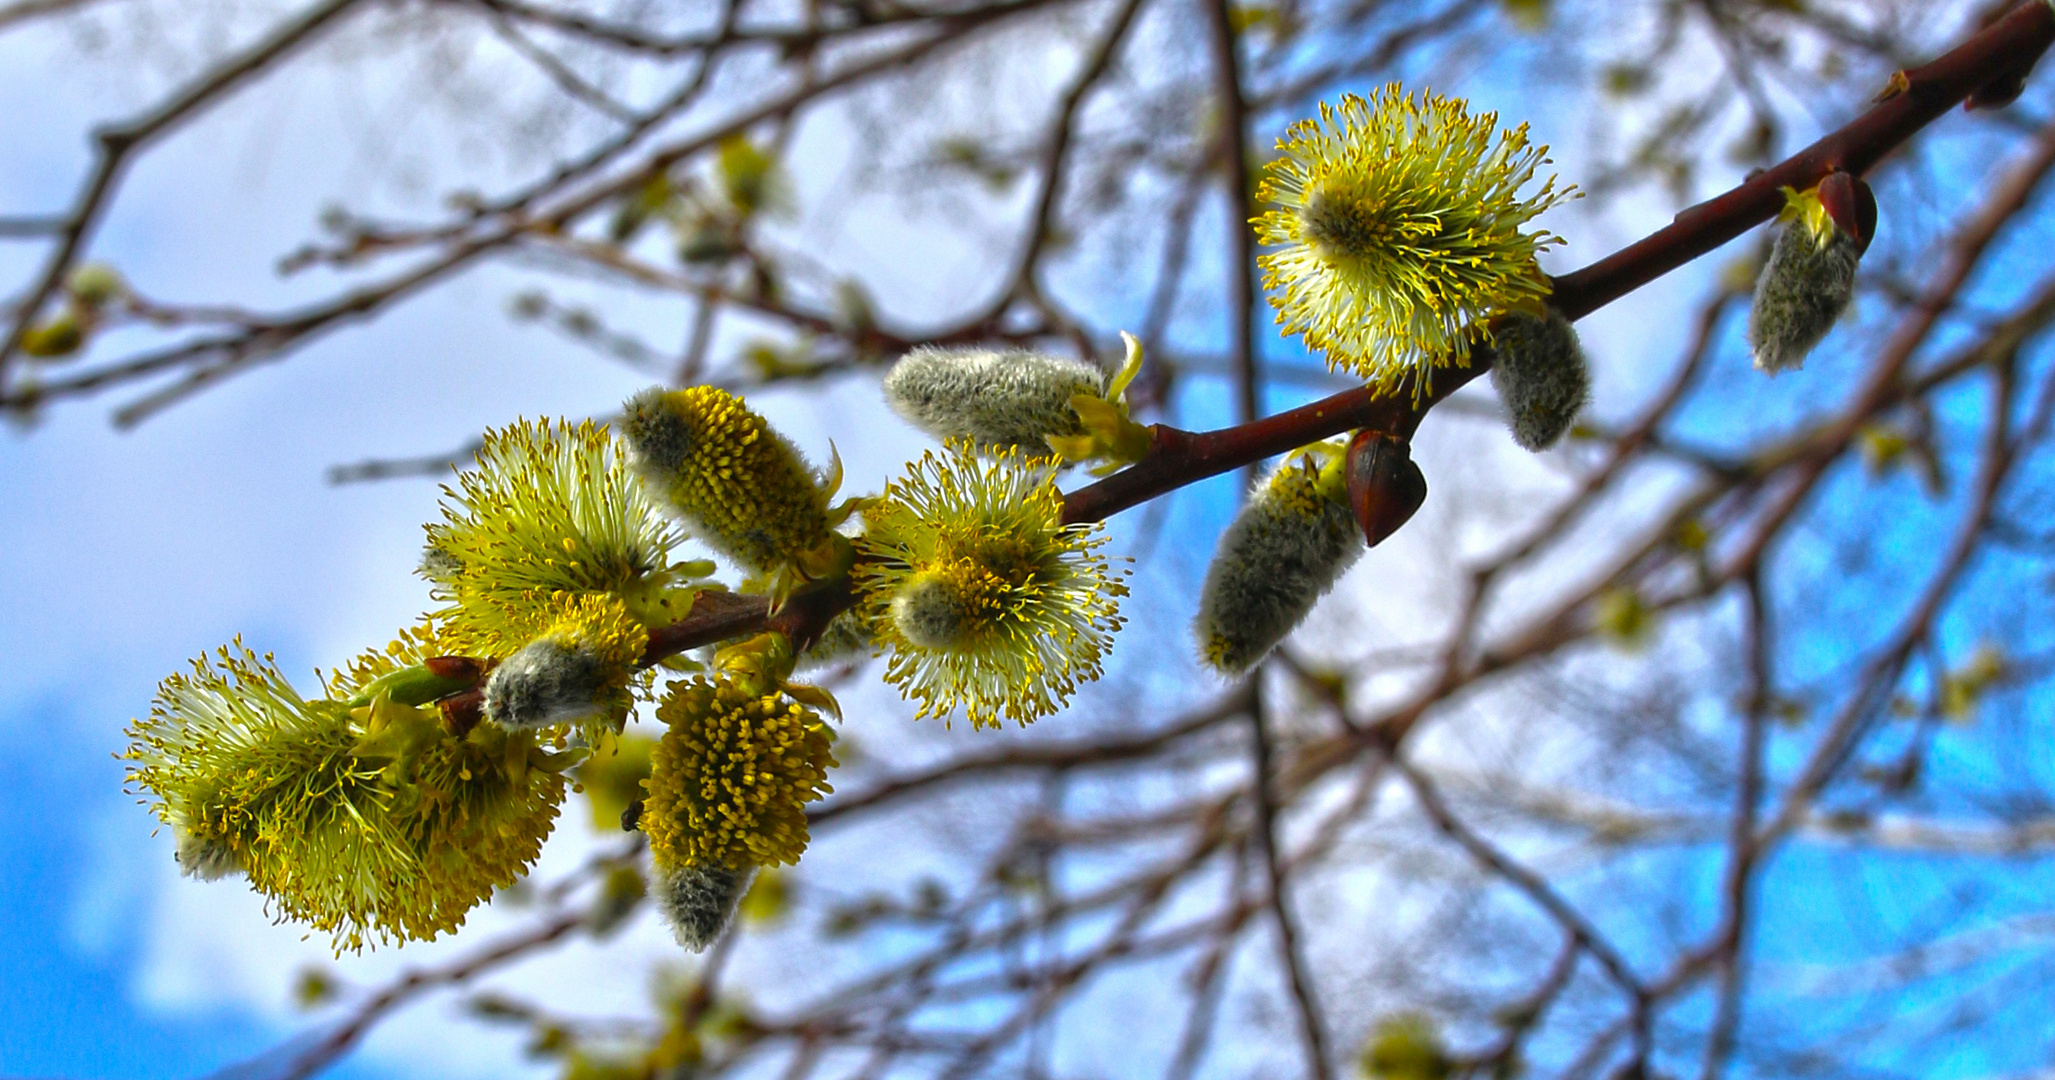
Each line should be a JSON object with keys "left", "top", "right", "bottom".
{"left": 1749, "top": 172, "right": 1876, "bottom": 376}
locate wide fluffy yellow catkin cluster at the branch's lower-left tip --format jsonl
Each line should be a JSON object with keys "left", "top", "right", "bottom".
{"left": 125, "top": 643, "right": 569, "bottom": 951}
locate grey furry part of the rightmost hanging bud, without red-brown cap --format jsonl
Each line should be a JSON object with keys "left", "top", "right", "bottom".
{"left": 1749, "top": 222, "right": 1862, "bottom": 376}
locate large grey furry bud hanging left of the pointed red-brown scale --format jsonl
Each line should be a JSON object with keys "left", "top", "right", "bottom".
{"left": 1194, "top": 456, "right": 1362, "bottom": 676}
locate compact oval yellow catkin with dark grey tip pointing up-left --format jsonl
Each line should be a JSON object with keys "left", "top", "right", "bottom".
{"left": 621, "top": 386, "right": 832, "bottom": 573}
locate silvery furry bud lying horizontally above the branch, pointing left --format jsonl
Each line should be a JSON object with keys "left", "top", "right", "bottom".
{"left": 886, "top": 347, "right": 1106, "bottom": 454}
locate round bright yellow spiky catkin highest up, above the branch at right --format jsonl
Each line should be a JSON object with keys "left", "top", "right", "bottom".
{"left": 1254, "top": 82, "right": 1574, "bottom": 394}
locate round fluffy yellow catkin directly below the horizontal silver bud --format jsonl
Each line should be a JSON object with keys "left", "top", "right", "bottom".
{"left": 855, "top": 441, "right": 1128, "bottom": 727}
